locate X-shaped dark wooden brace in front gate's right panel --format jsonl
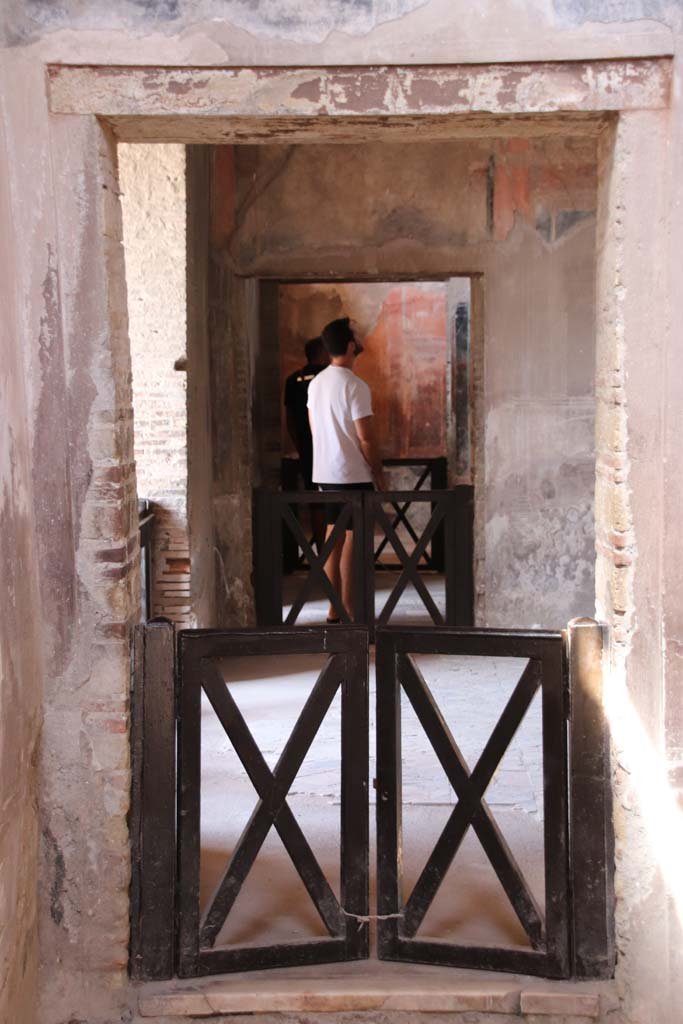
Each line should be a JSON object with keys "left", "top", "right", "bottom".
{"left": 398, "top": 654, "right": 544, "bottom": 949}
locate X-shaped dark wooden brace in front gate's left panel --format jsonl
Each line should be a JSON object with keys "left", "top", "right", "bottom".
{"left": 200, "top": 656, "right": 345, "bottom": 948}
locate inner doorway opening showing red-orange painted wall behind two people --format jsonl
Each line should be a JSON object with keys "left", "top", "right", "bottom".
{"left": 254, "top": 276, "right": 475, "bottom": 625}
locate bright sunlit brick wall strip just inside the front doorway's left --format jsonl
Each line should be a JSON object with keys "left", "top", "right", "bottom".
{"left": 119, "top": 143, "right": 189, "bottom": 628}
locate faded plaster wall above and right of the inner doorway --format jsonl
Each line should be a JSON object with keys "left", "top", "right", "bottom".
{"left": 224, "top": 137, "right": 596, "bottom": 628}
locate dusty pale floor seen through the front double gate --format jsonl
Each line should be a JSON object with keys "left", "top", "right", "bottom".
{"left": 201, "top": 581, "right": 544, "bottom": 946}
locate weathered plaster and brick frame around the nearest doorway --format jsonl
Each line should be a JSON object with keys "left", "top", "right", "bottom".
{"left": 41, "top": 59, "right": 671, "bottom": 991}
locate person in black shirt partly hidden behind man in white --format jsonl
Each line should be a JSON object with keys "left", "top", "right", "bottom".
{"left": 285, "top": 338, "right": 330, "bottom": 551}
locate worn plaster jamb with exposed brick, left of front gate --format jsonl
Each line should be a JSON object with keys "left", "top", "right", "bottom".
{"left": 34, "top": 108, "right": 139, "bottom": 1024}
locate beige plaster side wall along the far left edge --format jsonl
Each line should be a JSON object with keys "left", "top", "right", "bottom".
{"left": 0, "top": 94, "right": 43, "bottom": 1021}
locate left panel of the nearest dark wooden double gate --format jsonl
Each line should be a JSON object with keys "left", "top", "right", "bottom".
{"left": 178, "top": 627, "right": 369, "bottom": 977}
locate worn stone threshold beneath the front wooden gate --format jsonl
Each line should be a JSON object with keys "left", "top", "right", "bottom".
{"left": 138, "top": 961, "right": 618, "bottom": 1020}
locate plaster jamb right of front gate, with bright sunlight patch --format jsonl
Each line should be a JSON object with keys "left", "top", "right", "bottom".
{"left": 596, "top": 111, "right": 681, "bottom": 1024}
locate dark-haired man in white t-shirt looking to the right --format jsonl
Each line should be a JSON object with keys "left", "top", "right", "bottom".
{"left": 308, "top": 317, "right": 384, "bottom": 623}
